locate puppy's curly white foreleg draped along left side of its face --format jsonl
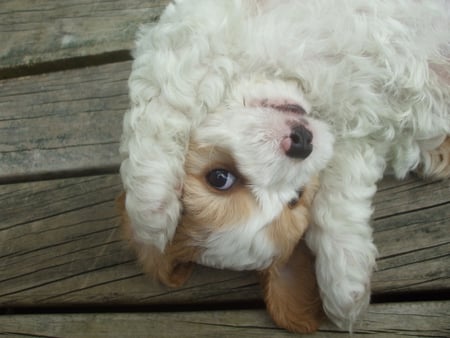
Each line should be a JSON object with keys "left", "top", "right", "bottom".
{"left": 119, "top": 1, "right": 234, "bottom": 252}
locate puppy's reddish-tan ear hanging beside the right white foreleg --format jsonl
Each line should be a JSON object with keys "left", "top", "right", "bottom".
{"left": 262, "top": 241, "right": 324, "bottom": 333}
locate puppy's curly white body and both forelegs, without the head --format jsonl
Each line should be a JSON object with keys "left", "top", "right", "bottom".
{"left": 121, "top": 0, "right": 450, "bottom": 325}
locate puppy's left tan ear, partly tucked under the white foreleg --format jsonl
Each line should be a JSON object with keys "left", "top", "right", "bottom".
{"left": 116, "top": 192, "right": 193, "bottom": 287}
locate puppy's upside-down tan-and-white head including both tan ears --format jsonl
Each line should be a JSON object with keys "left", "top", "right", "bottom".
{"left": 122, "top": 79, "right": 333, "bottom": 332}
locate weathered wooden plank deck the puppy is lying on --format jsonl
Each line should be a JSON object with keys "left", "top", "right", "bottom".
{"left": 0, "top": 0, "right": 450, "bottom": 337}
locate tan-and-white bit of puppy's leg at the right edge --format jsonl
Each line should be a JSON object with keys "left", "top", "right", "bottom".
{"left": 417, "top": 136, "right": 450, "bottom": 179}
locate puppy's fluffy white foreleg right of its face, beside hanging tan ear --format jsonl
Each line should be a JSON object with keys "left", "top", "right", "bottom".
{"left": 306, "top": 142, "right": 385, "bottom": 329}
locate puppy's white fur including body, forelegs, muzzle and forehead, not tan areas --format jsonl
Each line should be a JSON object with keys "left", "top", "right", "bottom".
{"left": 121, "top": 0, "right": 450, "bottom": 332}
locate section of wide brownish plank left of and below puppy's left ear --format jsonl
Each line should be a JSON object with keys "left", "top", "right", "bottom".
{"left": 0, "top": 175, "right": 260, "bottom": 307}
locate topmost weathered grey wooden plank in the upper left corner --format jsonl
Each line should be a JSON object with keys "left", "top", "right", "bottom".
{"left": 0, "top": 0, "right": 169, "bottom": 70}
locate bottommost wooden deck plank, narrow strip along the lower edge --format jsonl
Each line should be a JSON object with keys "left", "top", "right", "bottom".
{"left": 0, "top": 301, "right": 450, "bottom": 338}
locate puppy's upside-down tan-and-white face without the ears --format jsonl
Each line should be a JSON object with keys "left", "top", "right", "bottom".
{"left": 174, "top": 80, "right": 333, "bottom": 270}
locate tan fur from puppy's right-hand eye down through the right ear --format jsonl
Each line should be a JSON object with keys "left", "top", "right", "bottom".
{"left": 261, "top": 178, "right": 325, "bottom": 333}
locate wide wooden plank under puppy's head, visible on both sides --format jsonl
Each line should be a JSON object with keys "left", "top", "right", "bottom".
{"left": 0, "top": 175, "right": 450, "bottom": 307}
